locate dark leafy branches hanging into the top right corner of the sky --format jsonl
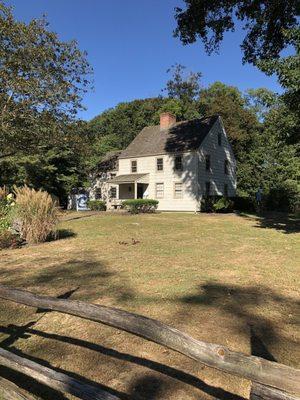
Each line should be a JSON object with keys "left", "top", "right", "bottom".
{"left": 174, "top": 0, "right": 300, "bottom": 63}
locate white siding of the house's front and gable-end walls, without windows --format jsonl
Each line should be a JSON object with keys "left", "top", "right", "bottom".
{"left": 118, "top": 118, "right": 236, "bottom": 211}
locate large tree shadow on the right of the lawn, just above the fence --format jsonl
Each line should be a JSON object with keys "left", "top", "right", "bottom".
{"left": 179, "top": 283, "right": 300, "bottom": 361}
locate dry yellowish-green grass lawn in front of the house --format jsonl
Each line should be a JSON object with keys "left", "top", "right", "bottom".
{"left": 0, "top": 213, "right": 300, "bottom": 400}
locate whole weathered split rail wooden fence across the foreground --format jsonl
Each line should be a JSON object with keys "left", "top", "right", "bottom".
{"left": 0, "top": 285, "right": 300, "bottom": 400}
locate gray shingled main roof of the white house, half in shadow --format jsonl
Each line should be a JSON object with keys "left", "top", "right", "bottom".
{"left": 119, "top": 115, "right": 218, "bottom": 158}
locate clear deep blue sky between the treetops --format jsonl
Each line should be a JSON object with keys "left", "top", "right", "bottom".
{"left": 6, "top": 0, "right": 280, "bottom": 119}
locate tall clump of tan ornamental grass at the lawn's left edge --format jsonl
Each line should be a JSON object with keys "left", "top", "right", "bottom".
{"left": 14, "top": 186, "right": 58, "bottom": 243}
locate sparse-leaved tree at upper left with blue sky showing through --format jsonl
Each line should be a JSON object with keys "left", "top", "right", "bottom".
{"left": 0, "top": 2, "right": 91, "bottom": 158}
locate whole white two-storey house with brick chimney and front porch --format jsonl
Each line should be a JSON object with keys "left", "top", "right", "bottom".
{"left": 92, "top": 113, "right": 236, "bottom": 211}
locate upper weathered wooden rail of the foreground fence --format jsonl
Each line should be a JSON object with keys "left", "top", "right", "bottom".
{"left": 0, "top": 285, "right": 300, "bottom": 400}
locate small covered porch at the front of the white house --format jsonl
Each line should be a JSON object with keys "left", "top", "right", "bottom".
{"left": 110, "top": 174, "right": 149, "bottom": 208}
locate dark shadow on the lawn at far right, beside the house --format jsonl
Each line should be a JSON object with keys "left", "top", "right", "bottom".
{"left": 238, "top": 212, "right": 300, "bottom": 234}
